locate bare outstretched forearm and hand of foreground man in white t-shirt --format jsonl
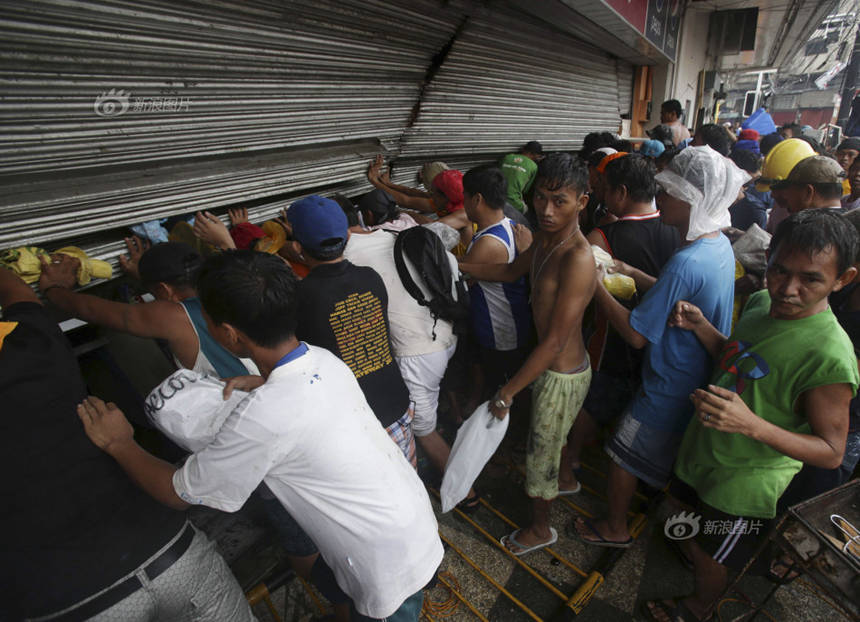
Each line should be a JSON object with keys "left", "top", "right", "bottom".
{"left": 78, "top": 397, "right": 190, "bottom": 510}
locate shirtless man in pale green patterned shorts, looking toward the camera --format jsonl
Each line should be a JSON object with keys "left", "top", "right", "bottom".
{"left": 460, "top": 153, "right": 597, "bottom": 556}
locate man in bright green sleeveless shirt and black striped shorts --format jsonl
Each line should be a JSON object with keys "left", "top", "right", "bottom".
{"left": 642, "top": 210, "right": 860, "bottom": 622}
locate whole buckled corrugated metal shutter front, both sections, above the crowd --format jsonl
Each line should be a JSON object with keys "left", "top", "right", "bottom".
{"left": 0, "top": 0, "right": 632, "bottom": 272}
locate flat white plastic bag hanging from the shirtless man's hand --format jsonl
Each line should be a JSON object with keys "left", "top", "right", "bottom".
{"left": 441, "top": 402, "right": 510, "bottom": 513}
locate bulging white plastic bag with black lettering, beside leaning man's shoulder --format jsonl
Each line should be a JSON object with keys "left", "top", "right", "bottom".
{"left": 144, "top": 369, "right": 248, "bottom": 452}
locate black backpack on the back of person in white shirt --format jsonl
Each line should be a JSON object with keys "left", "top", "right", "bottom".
{"left": 394, "top": 226, "right": 469, "bottom": 341}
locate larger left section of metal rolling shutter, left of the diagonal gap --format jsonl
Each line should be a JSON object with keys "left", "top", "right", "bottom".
{"left": 0, "top": 0, "right": 460, "bottom": 255}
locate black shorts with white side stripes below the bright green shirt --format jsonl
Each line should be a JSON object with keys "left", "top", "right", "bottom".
{"left": 664, "top": 478, "right": 774, "bottom": 570}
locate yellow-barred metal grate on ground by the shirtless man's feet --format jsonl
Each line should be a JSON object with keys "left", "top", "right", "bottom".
{"left": 425, "top": 450, "right": 646, "bottom": 622}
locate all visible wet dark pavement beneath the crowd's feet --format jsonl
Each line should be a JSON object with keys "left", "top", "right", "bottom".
{"left": 228, "top": 434, "right": 842, "bottom": 622}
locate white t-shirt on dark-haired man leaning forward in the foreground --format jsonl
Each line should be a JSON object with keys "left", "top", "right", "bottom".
{"left": 173, "top": 346, "right": 443, "bottom": 618}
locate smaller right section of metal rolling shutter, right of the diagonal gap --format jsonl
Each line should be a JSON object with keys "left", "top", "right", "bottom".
{"left": 394, "top": 10, "right": 620, "bottom": 176}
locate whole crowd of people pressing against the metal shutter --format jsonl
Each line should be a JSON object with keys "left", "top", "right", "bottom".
{"left": 0, "top": 100, "right": 860, "bottom": 622}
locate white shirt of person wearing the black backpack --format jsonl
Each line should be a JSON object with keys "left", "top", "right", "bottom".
{"left": 343, "top": 231, "right": 458, "bottom": 358}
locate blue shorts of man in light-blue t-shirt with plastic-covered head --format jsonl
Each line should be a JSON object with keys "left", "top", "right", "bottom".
{"left": 604, "top": 409, "right": 684, "bottom": 488}
